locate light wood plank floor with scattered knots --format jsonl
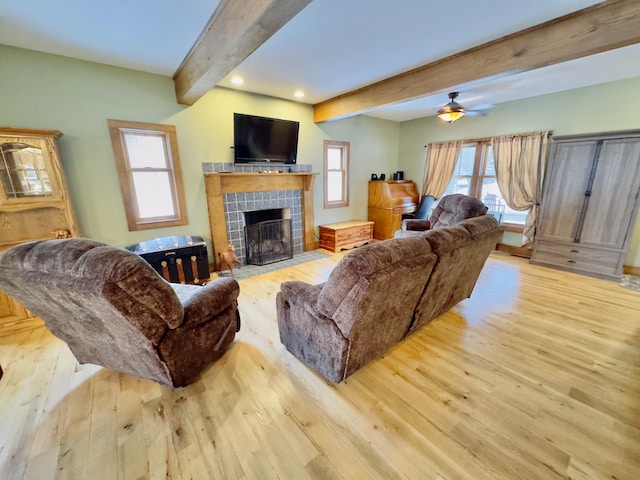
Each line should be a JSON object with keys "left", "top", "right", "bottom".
{"left": 0, "top": 253, "right": 640, "bottom": 480}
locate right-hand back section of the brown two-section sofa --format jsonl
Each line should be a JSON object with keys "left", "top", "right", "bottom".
{"left": 408, "top": 215, "right": 502, "bottom": 334}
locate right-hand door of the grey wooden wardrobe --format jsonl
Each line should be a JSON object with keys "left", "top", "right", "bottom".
{"left": 580, "top": 138, "right": 640, "bottom": 249}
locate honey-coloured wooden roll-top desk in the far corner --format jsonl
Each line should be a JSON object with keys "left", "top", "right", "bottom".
{"left": 368, "top": 180, "right": 418, "bottom": 240}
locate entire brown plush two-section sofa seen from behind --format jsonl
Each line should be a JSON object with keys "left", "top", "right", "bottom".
{"left": 276, "top": 216, "right": 502, "bottom": 382}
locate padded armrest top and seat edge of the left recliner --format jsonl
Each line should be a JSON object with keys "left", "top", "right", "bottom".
{"left": 171, "top": 278, "right": 240, "bottom": 327}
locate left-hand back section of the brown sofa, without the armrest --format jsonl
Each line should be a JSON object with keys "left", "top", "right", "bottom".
{"left": 316, "top": 237, "right": 436, "bottom": 377}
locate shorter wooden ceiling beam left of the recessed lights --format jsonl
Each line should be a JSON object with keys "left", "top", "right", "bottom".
{"left": 173, "top": 0, "right": 311, "bottom": 105}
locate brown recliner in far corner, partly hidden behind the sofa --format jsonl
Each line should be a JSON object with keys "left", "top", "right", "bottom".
{"left": 393, "top": 193, "right": 487, "bottom": 238}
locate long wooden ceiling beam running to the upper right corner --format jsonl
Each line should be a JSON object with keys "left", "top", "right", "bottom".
{"left": 313, "top": 0, "right": 640, "bottom": 123}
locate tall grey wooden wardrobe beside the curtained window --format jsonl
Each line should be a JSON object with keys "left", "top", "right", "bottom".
{"left": 531, "top": 131, "right": 640, "bottom": 280}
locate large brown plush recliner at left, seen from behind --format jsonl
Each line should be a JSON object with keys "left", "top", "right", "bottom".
{"left": 0, "top": 238, "right": 240, "bottom": 387}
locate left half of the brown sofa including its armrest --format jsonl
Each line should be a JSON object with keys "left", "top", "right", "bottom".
{"left": 276, "top": 237, "right": 436, "bottom": 382}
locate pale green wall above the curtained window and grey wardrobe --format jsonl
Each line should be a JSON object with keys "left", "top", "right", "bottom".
{"left": 398, "top": 78, "right": 640, "bottom": 267}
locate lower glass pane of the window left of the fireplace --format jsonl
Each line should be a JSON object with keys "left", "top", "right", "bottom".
{"left": 133, "top": 172, "right": 175, "bottom": 218}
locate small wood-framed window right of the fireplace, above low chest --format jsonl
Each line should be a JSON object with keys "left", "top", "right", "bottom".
{"left": 324, "top": 140, "right": 350, "bottom": 208}
